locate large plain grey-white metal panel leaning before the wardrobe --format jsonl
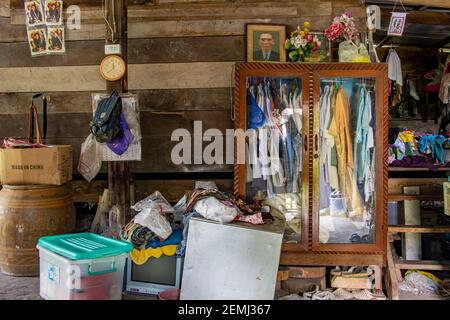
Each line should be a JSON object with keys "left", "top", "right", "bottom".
{"left": 181, "top": 218, "right": 284, "bottom": 300}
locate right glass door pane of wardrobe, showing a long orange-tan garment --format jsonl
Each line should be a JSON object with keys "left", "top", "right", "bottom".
{"left": 315, "top": 77, "right": 383, "bottom": 248}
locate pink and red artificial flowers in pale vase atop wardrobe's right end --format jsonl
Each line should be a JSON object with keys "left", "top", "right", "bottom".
{"left": 325, "top": 10, "right": 370, "bottom": 62}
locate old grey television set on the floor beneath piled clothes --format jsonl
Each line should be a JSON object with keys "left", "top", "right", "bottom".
{"left": 126, "top": 255, "right": 183, "bottom": 295}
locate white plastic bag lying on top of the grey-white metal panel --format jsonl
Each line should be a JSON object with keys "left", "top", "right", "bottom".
{"left": 194, "top": 197, "right": 240, "bottom": 223}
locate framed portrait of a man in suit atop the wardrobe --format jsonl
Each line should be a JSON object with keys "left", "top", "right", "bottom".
{"left": 246, "top": 24, "right": 286, "bottom": 62}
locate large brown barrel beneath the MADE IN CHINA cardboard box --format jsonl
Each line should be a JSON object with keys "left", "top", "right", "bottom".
{"left": 0, "top": 185, "right": 76, "bottom": 276}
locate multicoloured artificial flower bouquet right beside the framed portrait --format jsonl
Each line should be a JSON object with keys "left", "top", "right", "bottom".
{"left": 284, "top": 22, "right": 327, "bottom": 62}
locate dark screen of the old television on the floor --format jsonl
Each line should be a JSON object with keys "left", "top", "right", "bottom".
{"left": 131, "top": 255, "right": 177, "bottom": 286}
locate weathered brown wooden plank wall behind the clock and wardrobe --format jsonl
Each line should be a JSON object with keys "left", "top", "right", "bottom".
{"left": 0, "top": 0, "right": 365, "bottom": 201}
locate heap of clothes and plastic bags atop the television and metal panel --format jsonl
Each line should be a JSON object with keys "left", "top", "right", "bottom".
{"left": 120, "top": 187, "right": 274, "bottom": 265}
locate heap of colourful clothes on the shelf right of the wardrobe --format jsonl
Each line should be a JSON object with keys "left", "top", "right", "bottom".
{"left": 388, "top": 130, "right": 448, "bottom": 169}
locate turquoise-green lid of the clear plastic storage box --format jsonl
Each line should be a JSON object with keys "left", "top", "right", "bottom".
{"left": 38, "top": 232, "right": 133, "bottom": 260}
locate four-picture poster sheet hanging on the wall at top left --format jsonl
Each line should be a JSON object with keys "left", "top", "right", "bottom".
{"left": 25, "top": 0, "right": 66, "bottom": 57}
